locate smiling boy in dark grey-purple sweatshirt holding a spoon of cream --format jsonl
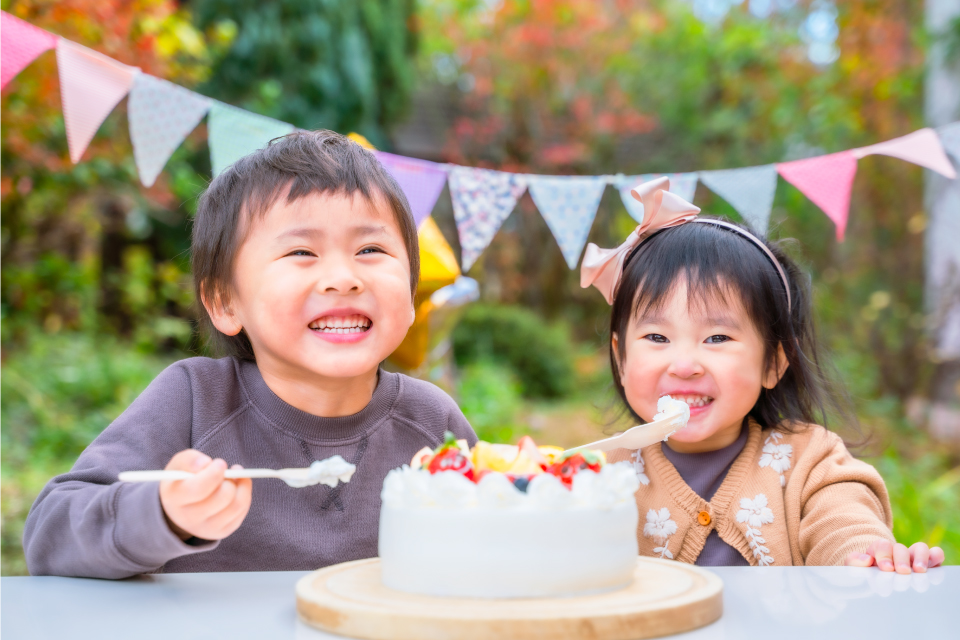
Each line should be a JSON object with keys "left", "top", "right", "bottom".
{"left": 24, "top": 131, "right": 476, "bottom": 578}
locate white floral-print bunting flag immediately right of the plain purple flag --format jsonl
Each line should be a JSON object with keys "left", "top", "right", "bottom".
{"left": 450, "top": 167, "right": 527, "bottom": 272}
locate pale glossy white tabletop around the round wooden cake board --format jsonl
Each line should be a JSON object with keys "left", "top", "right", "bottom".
{"left": 0, "top": 566, "right": 960, "bottom": 640}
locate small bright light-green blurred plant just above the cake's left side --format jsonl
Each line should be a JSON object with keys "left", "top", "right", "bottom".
{"left": 457, "top": 360, "right": 522, "bottom": 443}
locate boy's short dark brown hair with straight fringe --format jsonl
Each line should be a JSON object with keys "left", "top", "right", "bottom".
{"left": 191, "top": 130, "right": 420, "bottom": 360}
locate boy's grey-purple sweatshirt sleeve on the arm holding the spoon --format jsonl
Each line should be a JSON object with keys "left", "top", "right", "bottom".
{"left": 23, "top": 364, "right": 217, "bottom": 578}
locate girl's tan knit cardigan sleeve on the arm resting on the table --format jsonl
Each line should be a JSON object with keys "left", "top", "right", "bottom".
{"left": 799, "top": 432, "right": 894, "bottom": 566}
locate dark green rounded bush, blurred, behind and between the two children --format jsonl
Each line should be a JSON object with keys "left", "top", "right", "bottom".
{"left": 453, "top": 305, "right": 574, "bottom": 398}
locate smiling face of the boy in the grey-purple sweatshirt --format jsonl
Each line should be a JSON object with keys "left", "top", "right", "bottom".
{"left": 208, "top": 193, "right": 414, "bottom": 382}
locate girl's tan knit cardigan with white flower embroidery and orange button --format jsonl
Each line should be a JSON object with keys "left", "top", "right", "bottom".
{"left": 609, "top": 421, "right": 893, "bottom": 566}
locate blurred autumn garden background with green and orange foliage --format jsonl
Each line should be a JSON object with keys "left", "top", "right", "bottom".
{"left": 0, "top": 0, "right": 960, "bottom": 575}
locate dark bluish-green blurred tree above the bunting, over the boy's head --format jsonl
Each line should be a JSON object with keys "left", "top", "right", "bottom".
{"left": 189, "top": 0, "right": 417, "bottom": 148}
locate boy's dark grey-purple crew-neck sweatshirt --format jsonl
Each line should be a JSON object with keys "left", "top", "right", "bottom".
{"left": 23, "top": 358, "right": 477, "bottom": 578}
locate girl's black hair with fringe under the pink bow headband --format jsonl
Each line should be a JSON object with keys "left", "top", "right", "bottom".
{"left": 610, "top": 218, "right": 856, "bottom": 431}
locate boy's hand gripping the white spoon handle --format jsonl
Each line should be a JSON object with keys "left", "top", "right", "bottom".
{"left": 160, "top": 449, "right": 253, "bottom": 540}
